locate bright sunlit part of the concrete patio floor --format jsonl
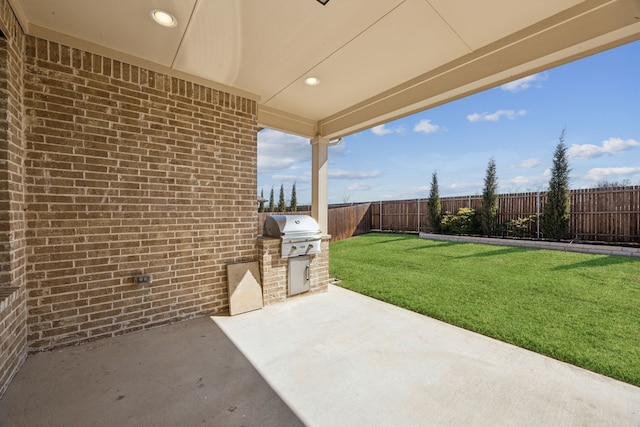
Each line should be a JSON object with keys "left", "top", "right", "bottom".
{"left": 214, "top": 286, "right": 640, "bottom": 427}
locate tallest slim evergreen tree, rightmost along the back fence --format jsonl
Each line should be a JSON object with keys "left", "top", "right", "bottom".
{"left": 542, "top": 130, "right": 571, "bottom": 240}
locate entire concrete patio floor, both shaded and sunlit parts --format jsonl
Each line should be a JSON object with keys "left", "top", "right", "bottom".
{"left": 0, "top": 286, "right": 640, "bottom": 426}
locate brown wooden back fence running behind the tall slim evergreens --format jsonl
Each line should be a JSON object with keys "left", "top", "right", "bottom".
{"left": 371, "top": 186, "right": 640, "bottom": 243}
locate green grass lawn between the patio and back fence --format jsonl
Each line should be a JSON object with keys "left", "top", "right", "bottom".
{"left": 330, "top": 233, "right": 640, "bottom": 386}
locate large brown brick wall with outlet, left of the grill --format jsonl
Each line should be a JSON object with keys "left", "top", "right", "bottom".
{"left": 24, "top": 37, "right": 257, "bottom": 350}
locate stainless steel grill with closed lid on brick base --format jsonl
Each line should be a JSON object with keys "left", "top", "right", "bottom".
{"left": 262, "top": 215, "right": 322, "bottom": 258}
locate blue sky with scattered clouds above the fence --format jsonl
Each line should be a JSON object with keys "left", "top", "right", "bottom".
{"left": 258, "top": 41, "right": 640, "bottom": 205}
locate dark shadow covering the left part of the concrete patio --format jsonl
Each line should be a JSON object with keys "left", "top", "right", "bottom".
{"left": 0, "top": 317, "right": 302, "bottom": 427}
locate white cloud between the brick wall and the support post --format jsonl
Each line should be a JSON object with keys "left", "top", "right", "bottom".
{"left": 258, "top": 129, "right": 311, "bottom": 173}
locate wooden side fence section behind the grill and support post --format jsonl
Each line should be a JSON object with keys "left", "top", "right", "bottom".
{"left": 258, "top": 203, "right": 371, "bottom": 242}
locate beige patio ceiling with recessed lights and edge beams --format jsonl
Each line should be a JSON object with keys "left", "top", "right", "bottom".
{"left": 10, "top": 0, "right": 640, "bottom": 138}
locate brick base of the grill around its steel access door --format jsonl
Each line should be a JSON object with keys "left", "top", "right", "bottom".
{"left": 258, "top": 236, "right": 331, "bottom": 305}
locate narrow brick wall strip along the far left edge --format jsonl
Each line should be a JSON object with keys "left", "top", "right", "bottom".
{"left": 0, "top": 0, "right": 27, "bottom": 397}
